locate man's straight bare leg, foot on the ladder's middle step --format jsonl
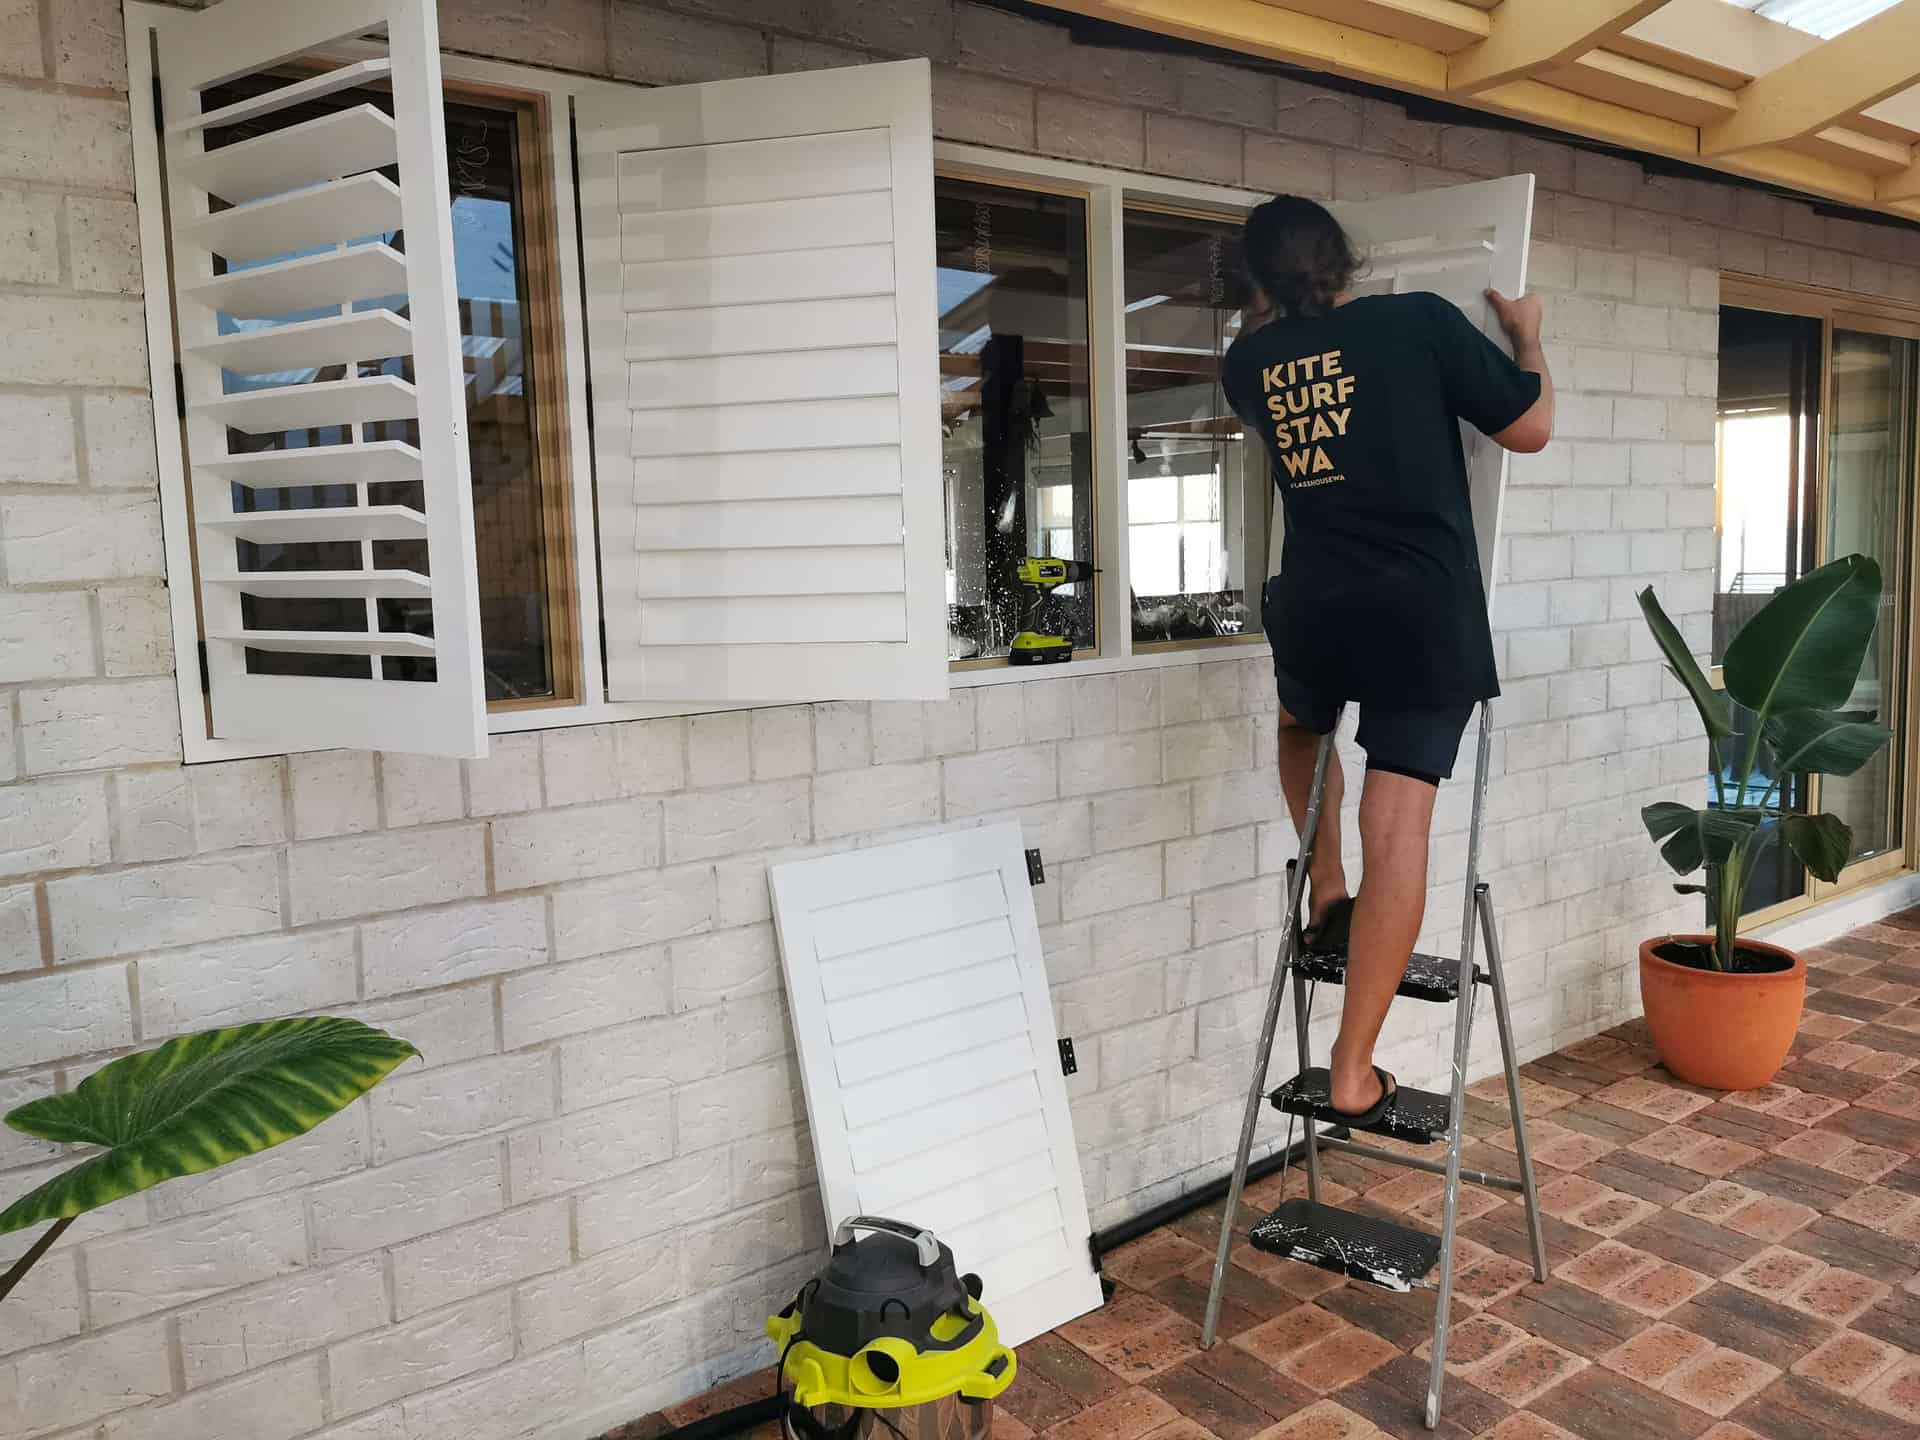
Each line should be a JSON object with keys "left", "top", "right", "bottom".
{"left": 1331, "top": 770, "right": 1438, "bottom": 1116}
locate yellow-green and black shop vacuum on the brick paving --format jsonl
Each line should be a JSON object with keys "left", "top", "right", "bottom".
{"left": 766, "top": 1215, "right": 1016, "bottom": 1440}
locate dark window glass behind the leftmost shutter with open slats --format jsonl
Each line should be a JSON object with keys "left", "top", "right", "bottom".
{"left": 204, "top": 77, "right": 557, "bottom": 701}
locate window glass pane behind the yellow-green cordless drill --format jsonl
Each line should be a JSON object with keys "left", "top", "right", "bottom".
{"left": 933, "top": 177, "right": 1098, "bottom": 660}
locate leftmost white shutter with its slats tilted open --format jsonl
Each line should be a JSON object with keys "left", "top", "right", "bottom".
{"left": 157, "top": 0, "right": 486, "bottom": 755}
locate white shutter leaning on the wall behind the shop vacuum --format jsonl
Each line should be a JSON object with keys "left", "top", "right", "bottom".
{"left": 772, "top": 824, "right": 1100, "bottom": 1344}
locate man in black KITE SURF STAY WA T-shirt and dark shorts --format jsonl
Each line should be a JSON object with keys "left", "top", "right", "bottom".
{"left": 1223, "top": 196, "right": 1553, "bottom": 1123}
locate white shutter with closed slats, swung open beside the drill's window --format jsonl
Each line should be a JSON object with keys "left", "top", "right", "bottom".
{"left": 576, "top": 60, "right": 947, "bottom": 701}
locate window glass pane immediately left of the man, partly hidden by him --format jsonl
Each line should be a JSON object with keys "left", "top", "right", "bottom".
{"left": 1123, "top": 209, "right": 1271, "bottom": 643}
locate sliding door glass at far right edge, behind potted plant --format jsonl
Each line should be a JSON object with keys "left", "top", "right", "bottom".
{"left": 1820, "top": 328, "right": 1920, "bottom": 860}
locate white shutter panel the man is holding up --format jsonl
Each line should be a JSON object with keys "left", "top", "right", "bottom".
{"left": 1267, "top": 175, "right": 1534, "bottom": 605}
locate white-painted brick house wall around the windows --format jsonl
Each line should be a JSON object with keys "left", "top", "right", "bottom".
{"left": 11, "top": 0, "right": 1920, "bottom": 1440}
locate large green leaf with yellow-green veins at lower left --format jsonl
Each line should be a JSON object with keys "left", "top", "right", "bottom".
{"left": 0, "top": 1018, "right": 419, "bottom": 1235}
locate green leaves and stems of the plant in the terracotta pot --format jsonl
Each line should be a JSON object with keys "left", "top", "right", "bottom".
{"left": 1640, "top": 555, "right": 1893, "bottom": 970}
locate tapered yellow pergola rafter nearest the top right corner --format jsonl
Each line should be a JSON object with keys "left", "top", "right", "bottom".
{"left": 1704, "top": 0, "right": 1920, "bottom": 156}
